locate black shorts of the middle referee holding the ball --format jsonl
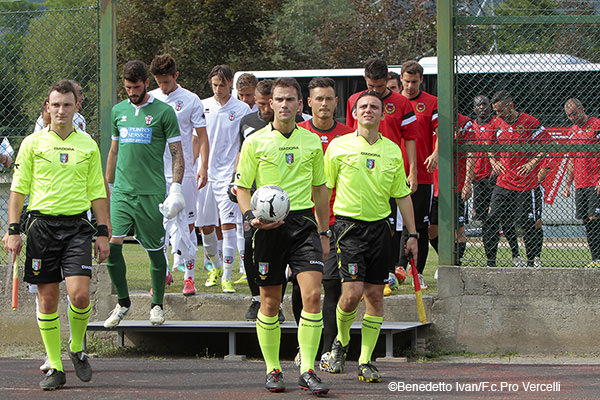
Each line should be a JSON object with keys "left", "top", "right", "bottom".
{"left": 252, "top": 210, "right": 324, "bottom": 286}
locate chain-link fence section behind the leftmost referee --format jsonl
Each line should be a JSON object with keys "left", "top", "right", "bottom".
{"left": 0, "top": 0, "right": 100, "bottom": 264}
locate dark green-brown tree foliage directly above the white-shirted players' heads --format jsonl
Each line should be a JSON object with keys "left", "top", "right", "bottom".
{"left": 117, "top": 0, "right": 281, "bottom": 96}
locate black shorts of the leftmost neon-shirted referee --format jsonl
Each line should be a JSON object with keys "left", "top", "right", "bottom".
{"left": 24, "top": 212, "right": 96, "bottom": 284}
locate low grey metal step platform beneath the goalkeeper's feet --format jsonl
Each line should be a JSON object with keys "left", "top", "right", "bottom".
{"left": 87, "top": 320, "right": 430, "bottom": 358}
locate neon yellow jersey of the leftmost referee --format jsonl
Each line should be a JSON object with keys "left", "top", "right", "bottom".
{"left": 10, "top": 128, "right": 106, "bottom": 215}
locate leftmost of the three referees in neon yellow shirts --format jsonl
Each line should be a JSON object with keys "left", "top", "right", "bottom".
{"left": 3, "top": 80, "right": 109, "bottom": 390}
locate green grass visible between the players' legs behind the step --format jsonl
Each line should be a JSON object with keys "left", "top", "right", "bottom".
{"left": 123, "top": 243, "right": 438, "bottom": 295}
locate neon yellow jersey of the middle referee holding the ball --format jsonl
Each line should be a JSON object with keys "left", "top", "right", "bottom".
{"left": 236, "top": 124, "right": 325, "bottom": 211}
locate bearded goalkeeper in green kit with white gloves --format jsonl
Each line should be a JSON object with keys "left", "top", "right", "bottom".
{"left": 104, "top": 60, "right": 185, "bottom": 328}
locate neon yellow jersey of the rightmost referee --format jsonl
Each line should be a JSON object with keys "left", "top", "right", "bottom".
{"left": 325, "top": 132, "right": 410, "bottom": 221}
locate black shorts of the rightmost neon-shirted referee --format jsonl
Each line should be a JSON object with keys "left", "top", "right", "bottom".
{"left": 334, "top": 216, "right": 396, "bottom": 285}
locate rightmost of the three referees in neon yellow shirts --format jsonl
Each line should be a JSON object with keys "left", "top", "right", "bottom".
{"left": 325, "top": 91, "right": 419, "bottom": 382}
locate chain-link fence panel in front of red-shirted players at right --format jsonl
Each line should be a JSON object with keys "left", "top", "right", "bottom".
{"left": 452, "top": 0, "right": 600, "bottom": 267}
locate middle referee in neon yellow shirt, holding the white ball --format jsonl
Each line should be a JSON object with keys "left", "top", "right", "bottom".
{"left": 235, "top": 78, "right": 330, "bottom": 394}
